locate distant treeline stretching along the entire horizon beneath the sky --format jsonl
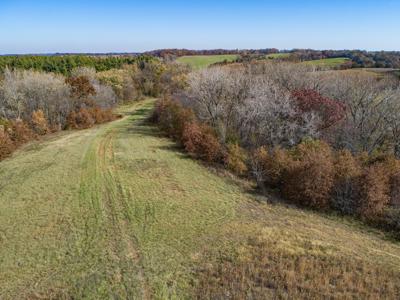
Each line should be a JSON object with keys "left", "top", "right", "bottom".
{"left": 0, "top": 48, "right": 400, "bottom": 76}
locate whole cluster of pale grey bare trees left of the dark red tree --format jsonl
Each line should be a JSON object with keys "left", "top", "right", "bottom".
{"left": 186, "top": 65, "right": 318, "bottom": 146}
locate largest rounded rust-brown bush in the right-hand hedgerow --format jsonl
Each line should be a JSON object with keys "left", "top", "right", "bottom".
{"left": 282, "top": 141, "right": 334, "bottom": 209}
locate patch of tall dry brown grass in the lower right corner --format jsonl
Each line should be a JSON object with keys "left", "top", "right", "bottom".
{"left": 193, "top": 227, "right": 400, "bottom": 299}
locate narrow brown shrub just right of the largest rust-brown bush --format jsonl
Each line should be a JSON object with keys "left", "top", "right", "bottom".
{"left": 331, "top": 150, "right": 362, "bottom": 214}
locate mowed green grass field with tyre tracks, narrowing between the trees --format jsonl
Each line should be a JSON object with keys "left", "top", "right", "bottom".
{"left": 0, "top": 100, "right": 400, "bottom": 299}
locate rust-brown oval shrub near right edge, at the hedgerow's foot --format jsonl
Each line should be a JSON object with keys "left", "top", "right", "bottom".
{"left": 356, "top": 163, "right": 390, "bottom": 220}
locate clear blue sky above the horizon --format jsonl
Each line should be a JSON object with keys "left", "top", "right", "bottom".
{"left": 0, "top": 0, "right": 400, "bottom": 54}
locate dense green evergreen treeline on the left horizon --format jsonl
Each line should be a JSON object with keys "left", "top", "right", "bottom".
{"left": 0, "top": 55, "right": 154, "bottom": 76}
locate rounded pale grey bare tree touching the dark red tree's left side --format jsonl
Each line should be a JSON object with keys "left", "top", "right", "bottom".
{"left": 237, "top": 77, "right": 319, "bottom": 146}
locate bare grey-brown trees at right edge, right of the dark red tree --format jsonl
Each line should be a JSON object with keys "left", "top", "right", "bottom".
{"left": 325, "top": 74, "right": 400, "bottom": 153}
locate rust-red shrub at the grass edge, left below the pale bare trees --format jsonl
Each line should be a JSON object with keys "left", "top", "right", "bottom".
{"left": 182, "top": 123, "right": 222, "bottom": 162}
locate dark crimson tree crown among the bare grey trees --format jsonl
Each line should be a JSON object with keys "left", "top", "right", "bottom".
{"left": 292, "top": 90, "right": 346, "bottom": 129}
